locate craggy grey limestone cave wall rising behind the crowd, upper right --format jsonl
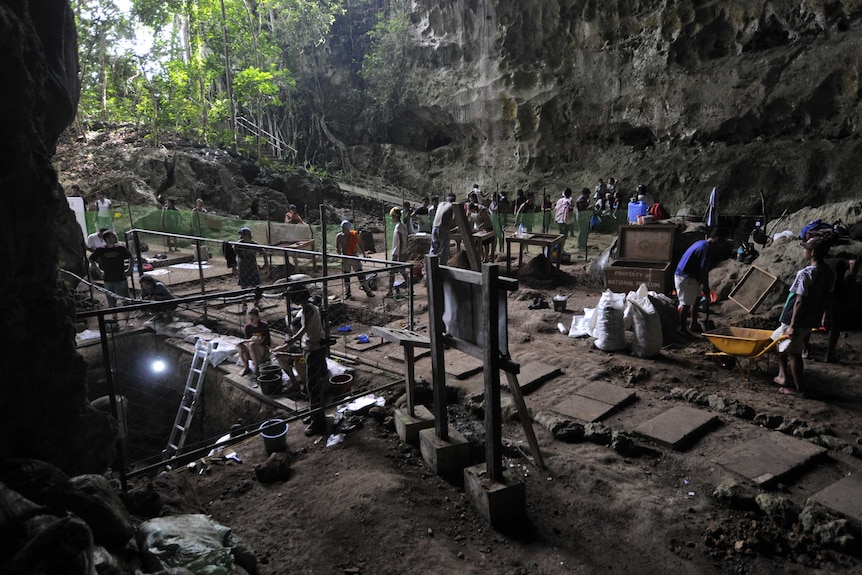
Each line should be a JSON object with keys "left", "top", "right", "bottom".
{"left": 340, "top": 0, "right": 862, "bottom": 214}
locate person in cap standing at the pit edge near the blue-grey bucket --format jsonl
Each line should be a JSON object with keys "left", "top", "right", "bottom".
{"left": 272, "top": 285, "right": 329, "bottom": 437}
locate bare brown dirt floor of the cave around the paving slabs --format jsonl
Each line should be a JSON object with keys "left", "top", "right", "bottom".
{"left": 130, "top": 233, "right": 862, "bottom": 575}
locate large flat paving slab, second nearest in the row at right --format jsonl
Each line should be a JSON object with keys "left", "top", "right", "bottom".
{"left": 716, "top": 431, "right": 826, "bottom": 485}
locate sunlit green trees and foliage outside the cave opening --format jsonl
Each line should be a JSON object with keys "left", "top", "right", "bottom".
{"left": 72, "top": 0, "right": 412, "bottom": 170}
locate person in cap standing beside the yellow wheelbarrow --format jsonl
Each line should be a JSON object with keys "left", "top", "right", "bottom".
{"left": 772, "top": 238, "right": 835, "bottom": 395}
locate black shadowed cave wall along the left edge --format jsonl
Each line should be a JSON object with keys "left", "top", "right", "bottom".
{"left": 0, "top": 0, "right": 117, "bottom": 474}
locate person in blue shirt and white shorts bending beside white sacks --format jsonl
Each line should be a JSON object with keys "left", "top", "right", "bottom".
{"left": 674, "top": 228, "right": 729, "bottom": 337}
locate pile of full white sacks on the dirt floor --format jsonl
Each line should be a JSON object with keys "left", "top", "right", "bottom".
{"left": 569, "top": 284, "right": 678, "bottom": 357}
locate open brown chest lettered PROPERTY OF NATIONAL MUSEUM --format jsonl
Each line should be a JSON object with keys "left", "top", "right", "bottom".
{"left": 606, "top": 224, "right": 676, "bottom": 293}
